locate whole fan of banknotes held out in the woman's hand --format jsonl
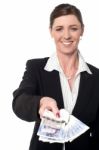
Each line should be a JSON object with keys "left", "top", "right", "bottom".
{"left": 37, "top": 109, "right": 89, "bottom": 143}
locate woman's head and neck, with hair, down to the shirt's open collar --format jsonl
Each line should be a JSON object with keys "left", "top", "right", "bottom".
{"left": 50, "top": 4, "right": 84, "bottom": 88}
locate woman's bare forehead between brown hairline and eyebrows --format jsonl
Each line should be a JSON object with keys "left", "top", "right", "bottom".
{"left": 53, "top": 15, "right": 81, "bottom": 26}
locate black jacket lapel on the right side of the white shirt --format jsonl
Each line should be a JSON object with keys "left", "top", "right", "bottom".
{"left": 73, "top": 72, "right": 93, "bottom": 118}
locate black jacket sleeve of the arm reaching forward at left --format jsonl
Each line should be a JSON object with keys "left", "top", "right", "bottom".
{"left": 12, "top": 60, "right": 42, "bottom": 121}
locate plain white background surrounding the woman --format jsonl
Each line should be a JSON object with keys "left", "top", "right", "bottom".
{"left": 0, "top": 0, "right": 99, "bottom": 150}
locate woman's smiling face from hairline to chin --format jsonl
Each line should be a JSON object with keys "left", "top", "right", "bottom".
{"left": 50, "top": 15, "right": 83, "bottom": 55}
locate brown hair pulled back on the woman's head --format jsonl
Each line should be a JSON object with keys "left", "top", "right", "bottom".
{"left": 50, "top": 4, "right": 84, "bottom": 28}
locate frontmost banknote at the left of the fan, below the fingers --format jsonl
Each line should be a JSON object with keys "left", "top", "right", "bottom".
{"left": 37, "top": 113, "right": 66, "bottom": 140}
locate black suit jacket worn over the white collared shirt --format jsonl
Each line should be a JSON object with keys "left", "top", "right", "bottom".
{"left": 13, "top": 58, "right": 99, "bottom": 150}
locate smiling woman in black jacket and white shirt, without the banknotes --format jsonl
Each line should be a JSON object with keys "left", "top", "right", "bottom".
{"left": 13, "top": 4, "right": 99, "bottom": 150}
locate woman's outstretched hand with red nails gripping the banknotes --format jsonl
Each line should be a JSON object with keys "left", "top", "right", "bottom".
{"left": 39, "top": 97, "right": 59, "bottom": 118}
